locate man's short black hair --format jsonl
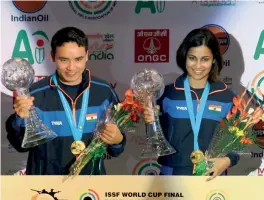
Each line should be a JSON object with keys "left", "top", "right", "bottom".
{"left": 51, "top": 27, "right": 88, "bottom": 55}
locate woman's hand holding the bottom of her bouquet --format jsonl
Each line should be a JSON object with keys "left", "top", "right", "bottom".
{"left": 203, "top": 157, "right": 231, "bottom": 181}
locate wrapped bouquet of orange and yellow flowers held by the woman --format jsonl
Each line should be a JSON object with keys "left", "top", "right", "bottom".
{"left": 191, "top": 90, "right": 264, "bottom": 176}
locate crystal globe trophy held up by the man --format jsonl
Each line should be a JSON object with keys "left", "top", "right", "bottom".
{"left": 1, "top": 58, "right": 57, "bottom": 148}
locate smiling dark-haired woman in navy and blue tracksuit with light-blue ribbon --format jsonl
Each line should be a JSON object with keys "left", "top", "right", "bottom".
{"left": 144, "top": 29, "right": 239, "bottom": 180}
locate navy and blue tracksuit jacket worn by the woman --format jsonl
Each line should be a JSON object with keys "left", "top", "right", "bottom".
{"left": 158, "top": 74, "right": 239, "bottom": 175}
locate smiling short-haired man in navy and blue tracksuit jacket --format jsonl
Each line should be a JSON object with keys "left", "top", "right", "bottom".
{"left": 6, "top": 27, "right": 126, "bottom": 175}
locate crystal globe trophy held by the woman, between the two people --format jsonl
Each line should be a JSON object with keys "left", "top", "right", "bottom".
{"left": 131, "top": 69, "right": 176, "bottom": 158}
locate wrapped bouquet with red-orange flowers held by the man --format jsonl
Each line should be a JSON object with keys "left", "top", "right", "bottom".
{"left": 64, "top": 89, "right": 143, "bottom": 181}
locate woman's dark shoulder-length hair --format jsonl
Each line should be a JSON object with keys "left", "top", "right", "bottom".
{"left": 176, "top": 28, "right": 223, "bottom": 83}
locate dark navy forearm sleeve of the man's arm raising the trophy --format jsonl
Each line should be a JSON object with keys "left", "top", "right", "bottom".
{"left": 6, "top": 113, "right": 28, "bottom": 152}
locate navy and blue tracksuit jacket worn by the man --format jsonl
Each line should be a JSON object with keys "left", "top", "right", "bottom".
{"left": 6, "top": 70, "right": 126, "bottom": 175}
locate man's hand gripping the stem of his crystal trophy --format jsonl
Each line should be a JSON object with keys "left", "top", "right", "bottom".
{"left": 14, "top": 96, "right": 34, "bottom": 118}
